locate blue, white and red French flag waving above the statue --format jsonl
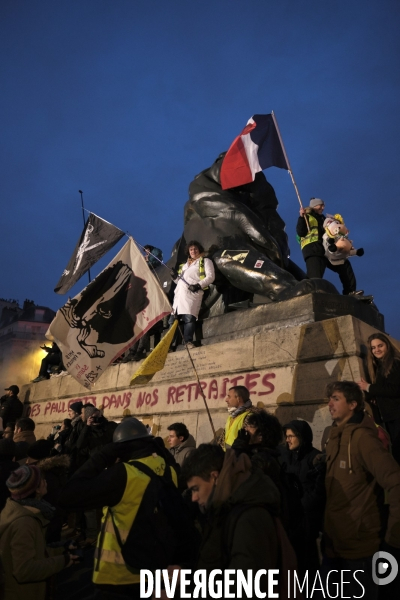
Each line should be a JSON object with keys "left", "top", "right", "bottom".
{"left": 220, "top": 114, "right": 291, "bottom": 190}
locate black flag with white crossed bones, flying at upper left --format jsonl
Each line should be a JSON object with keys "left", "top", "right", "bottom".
{"left": 54, "top": 213, "right": 125, "bottom": 294}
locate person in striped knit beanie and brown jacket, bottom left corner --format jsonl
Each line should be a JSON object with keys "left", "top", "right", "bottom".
{"left": 0, "top": 465, "right": 79, "bottom": 600}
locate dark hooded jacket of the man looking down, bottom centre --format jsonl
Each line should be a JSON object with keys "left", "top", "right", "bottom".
{"left": 196, "top": 449, "right": 280, "bottom": 572}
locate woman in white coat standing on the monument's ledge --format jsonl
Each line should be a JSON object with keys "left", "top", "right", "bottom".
{"left": 171, "top": 240, "right": 215, "bottom": 347}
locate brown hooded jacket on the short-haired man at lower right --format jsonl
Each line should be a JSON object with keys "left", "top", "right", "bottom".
{"left": 325, "top": 413, "right": 400, "bottom": 559}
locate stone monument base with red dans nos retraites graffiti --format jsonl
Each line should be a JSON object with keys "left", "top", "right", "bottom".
{"left": 20, "top": 294, "right": 390, "bottom": 447}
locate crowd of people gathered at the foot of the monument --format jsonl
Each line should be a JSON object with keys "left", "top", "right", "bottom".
{"left": 0, "top": 352, "right": 400, "bottom": 600}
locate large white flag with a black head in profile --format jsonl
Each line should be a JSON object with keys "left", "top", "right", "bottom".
{"left": 46, "top": 238, "right": 171, "bottom": 389}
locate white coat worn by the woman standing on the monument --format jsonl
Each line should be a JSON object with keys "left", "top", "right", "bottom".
{"left": 172, "top": 257, "right": 215, "bottom": 319}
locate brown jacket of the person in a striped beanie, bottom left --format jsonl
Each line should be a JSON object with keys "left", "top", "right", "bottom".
{"left": 0, "top": 498, "right": 69, "bottom": 600}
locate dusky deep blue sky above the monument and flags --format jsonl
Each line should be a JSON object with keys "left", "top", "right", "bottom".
{"left": 0, "top": 0, "right": 400, "bottom": 339}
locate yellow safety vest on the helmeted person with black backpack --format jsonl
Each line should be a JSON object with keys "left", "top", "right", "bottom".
{"left": 93, "top": 455, "right": 178, "bottom": 585}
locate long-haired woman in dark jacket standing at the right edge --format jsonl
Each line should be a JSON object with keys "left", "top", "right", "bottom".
{"left": 358, "top": 333, "right": 400, "bottom": 463}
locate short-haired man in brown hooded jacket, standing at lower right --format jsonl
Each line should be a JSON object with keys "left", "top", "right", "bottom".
{"left": 322, "top": 381, "right": 400, "bottom": 600}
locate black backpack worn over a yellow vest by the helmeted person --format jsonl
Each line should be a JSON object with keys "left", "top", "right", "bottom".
{"left": 109, "top": 460, "right": 200, "bottom": 573}
